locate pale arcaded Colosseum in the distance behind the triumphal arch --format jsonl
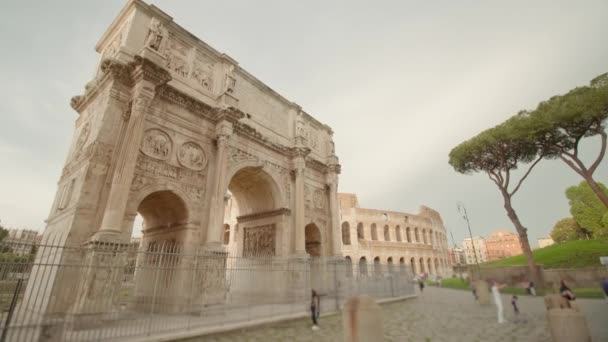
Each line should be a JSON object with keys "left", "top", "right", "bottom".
{"left": 338, "top": 194, "right": 452, "bottom": 276}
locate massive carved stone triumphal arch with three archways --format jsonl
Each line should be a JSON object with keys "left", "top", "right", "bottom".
{"left": 21, "top": 0, "right": 341, "bottom": 332}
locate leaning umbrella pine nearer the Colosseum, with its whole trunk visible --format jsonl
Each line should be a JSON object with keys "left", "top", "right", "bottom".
{"left": 449, "top": 115, "right": 543, "bottom": 284}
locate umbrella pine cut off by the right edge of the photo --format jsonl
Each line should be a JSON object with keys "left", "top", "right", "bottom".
{"left": 522, "top": 73, "right": 608, "bottom": 208}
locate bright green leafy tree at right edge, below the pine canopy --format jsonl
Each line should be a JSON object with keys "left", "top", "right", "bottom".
{"left": 566, "top": 181, "right": 608, "bottom": 237}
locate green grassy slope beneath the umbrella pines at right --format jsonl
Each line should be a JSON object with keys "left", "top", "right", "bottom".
{"left": 482, "top": 239, "right": 608, "bottom": 269}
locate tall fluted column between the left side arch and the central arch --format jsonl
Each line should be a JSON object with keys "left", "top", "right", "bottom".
{"left": 206, "top": 121, "right": 233, "bottom": 249}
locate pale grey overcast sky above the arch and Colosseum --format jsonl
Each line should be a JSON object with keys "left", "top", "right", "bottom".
{"left": 0, "top": 0, "right": 608, "bottom": 246}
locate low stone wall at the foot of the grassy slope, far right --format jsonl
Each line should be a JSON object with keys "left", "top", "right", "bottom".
{"left": 544, "top": 267, "right": 608, "bottom": 288}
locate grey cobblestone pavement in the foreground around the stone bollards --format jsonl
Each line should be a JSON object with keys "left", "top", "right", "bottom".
{"left": 187, "top": 288, "right": 608, "bottom": 342}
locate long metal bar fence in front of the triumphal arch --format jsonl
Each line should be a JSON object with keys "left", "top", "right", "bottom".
{"left": 0, "top": 238, "right": 414, "bottom": 342}
